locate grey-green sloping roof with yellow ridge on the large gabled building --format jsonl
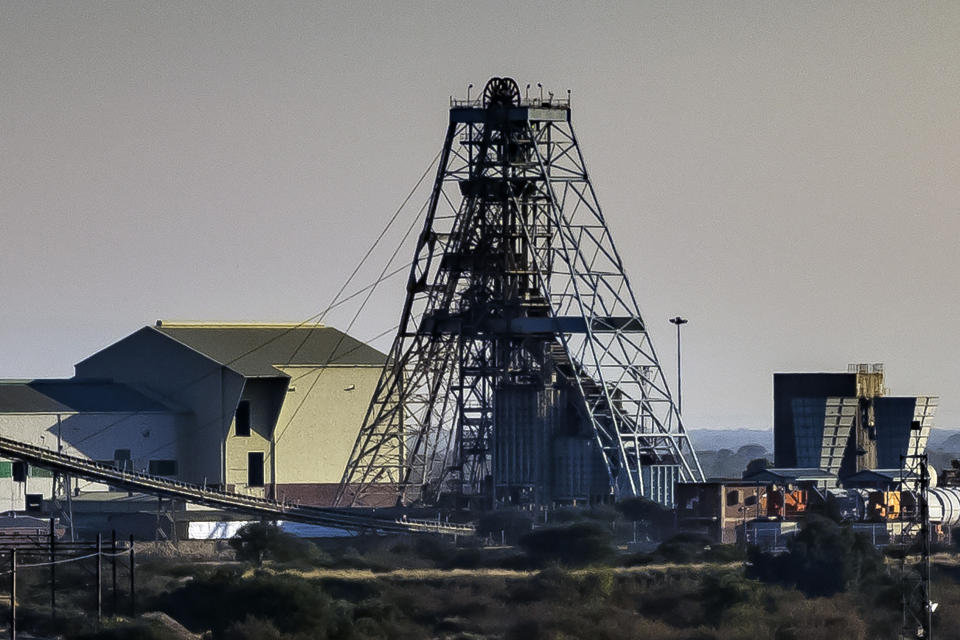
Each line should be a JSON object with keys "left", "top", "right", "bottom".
{"left": 155, "top": 322, "right": 387, "bottom": 378}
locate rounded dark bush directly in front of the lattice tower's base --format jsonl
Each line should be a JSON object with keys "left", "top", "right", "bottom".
{"left": 520, "top": 522, "right": 613, "bottom": 566}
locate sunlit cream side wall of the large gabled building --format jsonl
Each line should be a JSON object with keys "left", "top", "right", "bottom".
{"left": 274, "top": 366, "right": 381, "bottom": 486}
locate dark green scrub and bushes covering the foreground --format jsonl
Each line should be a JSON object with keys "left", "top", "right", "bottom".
{"left": 0, "top": 516, "right": 960, "bottom": 640}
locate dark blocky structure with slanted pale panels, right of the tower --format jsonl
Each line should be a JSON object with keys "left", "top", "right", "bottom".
{"left": 773, "top": 364, "right": 937, "bottom": 479}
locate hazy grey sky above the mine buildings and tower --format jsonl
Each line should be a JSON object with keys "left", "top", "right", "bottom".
{"left": 0, "top": 1, "right": 960, "bottom": 428}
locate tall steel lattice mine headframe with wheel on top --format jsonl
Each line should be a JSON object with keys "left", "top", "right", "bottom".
{"left": 337, "top": 78, "right": 703, "bottom": 506}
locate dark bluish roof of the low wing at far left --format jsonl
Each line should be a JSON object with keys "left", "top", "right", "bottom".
{"left": 0, "top": 379, "right": 170, "bottom": 413}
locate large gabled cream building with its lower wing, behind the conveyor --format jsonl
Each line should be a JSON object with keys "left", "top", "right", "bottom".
{"left": 0, "top": 322, "right": 385, "bottom": 510}
